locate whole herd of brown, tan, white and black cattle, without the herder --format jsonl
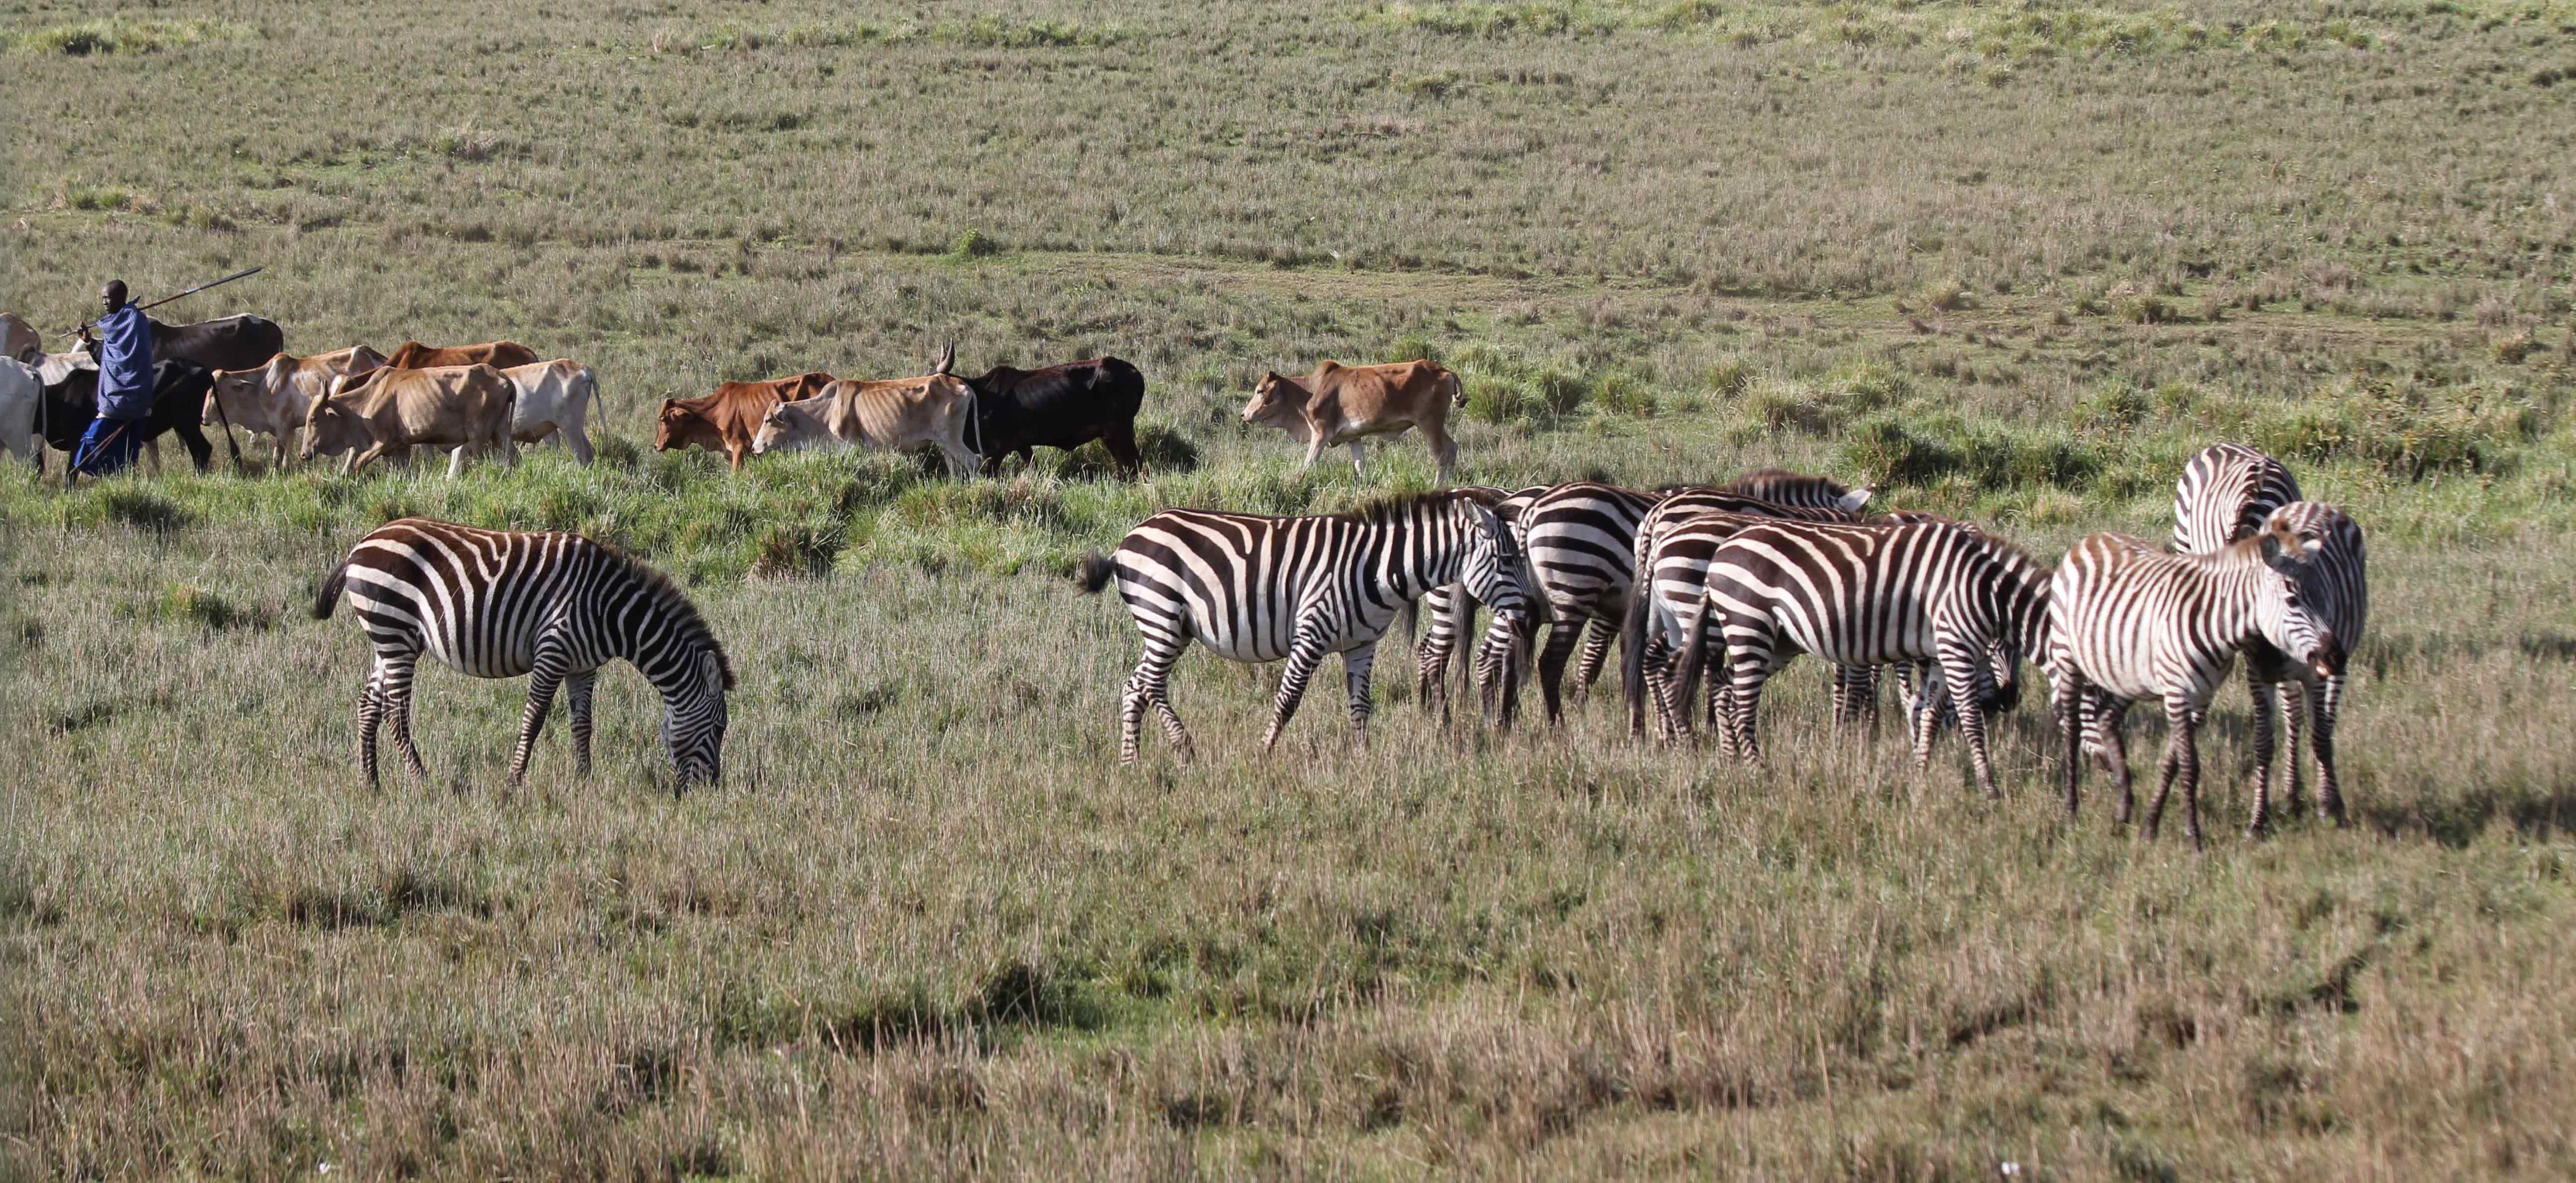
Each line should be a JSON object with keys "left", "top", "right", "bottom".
{"left": 0, "top": 312, "right": 1463, "bottom": 480}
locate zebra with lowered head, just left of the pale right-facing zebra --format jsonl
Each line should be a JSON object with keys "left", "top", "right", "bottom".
{"left": 1659, "top": 521, "right": 2048, "bottom": 796}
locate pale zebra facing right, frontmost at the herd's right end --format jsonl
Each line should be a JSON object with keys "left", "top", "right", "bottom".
{"left": 2048, "top": 503, "right": 2360, "bottom": 848}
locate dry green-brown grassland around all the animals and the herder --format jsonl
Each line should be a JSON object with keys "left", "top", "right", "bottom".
{"left": 0, "top": 0, "right": 2576, "bottom": 1181}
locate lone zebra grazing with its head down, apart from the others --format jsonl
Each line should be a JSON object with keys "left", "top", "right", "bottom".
{"left": 314, "top": 518, "right": 734, "bottom": 786}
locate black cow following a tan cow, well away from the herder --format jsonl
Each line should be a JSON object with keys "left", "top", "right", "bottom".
{"left": 938, "top": 345, "right": 1144, "bottom": 477}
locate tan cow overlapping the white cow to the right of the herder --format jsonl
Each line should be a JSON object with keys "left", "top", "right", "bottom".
{"left": 302, "top": 366, "right": 518, "bottom": 480}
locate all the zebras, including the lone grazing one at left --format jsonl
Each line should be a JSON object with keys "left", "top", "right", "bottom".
{"left": 314, "top": 444, "right": 2367, "bottom": 845}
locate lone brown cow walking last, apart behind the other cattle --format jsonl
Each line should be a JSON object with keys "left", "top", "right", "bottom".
{"left": 1244, "top": 361, "right": 1466, "bottom": 482}
